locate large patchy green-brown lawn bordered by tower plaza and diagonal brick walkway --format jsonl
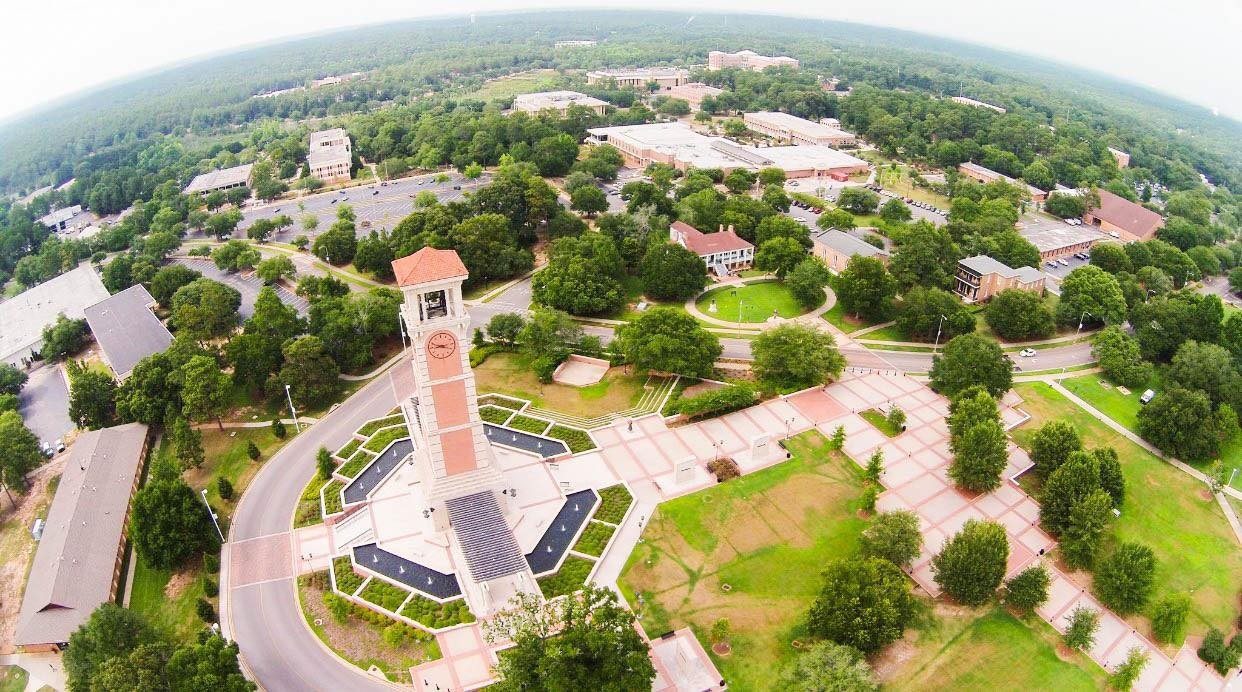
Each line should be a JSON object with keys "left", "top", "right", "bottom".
{"left": 620, "top": 432, "right": 866, "bottom": 690}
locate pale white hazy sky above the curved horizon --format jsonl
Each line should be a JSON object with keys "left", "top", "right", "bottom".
{"left": 0, "top": 0, "right": 1242, "bottom": 119}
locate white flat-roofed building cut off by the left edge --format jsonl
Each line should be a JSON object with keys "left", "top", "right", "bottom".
{"left": 0, "top": 263, "right": 108, "bottom": 368}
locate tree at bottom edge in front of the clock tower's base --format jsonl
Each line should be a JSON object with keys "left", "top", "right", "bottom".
{"left": 487, "top": 584, "right": 656, "bottom": 692}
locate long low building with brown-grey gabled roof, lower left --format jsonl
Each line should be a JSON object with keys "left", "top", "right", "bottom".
{"left": 14, "top": 422, "right": 149, "bottom": 652}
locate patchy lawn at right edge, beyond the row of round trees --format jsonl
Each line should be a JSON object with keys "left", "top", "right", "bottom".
{"left": 1013, "top": 383, "right": 1242, "bottom": 634}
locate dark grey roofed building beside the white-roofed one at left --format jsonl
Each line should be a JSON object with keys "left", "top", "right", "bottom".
{"left": 86, "top": 283, "right": 173, "bottom": 381}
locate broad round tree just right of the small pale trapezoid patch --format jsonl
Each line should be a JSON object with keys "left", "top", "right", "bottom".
{"left": 617, "top": 307, "right": 722, "bottom": 378}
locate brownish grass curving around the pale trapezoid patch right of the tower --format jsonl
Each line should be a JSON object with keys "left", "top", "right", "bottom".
{"left": 474, "top": 353, "right": 647, "bottom": 417}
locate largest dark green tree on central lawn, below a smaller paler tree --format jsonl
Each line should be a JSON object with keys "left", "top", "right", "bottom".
{"left": 806, "top": 558, "right": 915, "bottom": 653}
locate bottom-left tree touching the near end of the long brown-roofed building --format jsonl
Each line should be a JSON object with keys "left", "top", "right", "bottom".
{"left": 62, "top": 601, "right": 155, "bottom": 690}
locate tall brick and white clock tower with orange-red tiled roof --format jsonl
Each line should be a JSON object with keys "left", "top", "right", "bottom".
{"left": 392, "top": 247, "right": 508, "bottom": 530}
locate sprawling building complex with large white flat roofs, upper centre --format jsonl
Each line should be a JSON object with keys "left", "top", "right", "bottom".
{"left": 586, "top": 122, "right": 869, "bottom": 178}
